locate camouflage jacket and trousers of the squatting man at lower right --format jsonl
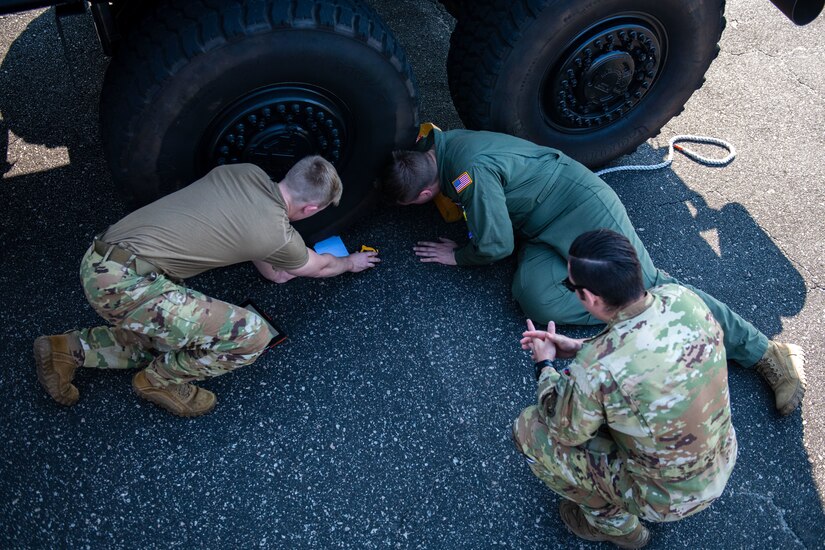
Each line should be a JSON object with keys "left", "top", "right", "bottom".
{"left": 513, "top": 285, "right": 737, "bottom": 535}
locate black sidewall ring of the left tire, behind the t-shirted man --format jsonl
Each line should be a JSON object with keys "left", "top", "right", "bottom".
{"left": 114, "top": 29, "right": 417, "bottom": 237}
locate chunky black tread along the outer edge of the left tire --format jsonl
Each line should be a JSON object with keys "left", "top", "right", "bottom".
{"left": 100, "top": 0, "right": 419, "bottom": 199}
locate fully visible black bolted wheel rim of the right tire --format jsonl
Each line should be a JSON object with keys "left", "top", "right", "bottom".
{"left": 541, "top": 14, "right": 667, "bottom": 133}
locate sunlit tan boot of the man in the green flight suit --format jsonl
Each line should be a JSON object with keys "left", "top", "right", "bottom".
{"left": 755, "top": 341, "right": 805, "bottom": 415}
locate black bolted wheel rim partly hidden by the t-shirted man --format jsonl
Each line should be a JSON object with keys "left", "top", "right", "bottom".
{"left": 204, "top": 84, "right": 350, "bottom": 180}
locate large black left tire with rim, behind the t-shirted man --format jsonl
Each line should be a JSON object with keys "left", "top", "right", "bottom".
{"left": 101, "top": 0, "right": 418, "bottom": 241}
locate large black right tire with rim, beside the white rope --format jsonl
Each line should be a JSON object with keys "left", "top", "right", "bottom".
{"left": 448, "top": 0, "right": 725, "bottom": 167}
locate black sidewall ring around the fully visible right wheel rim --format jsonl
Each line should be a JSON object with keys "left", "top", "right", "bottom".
{"left": 492, "top": 0, "right": 720, "bottom": 166}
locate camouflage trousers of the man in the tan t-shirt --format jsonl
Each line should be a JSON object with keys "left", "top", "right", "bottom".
{"left": 80, "top": 247, "right": 272, "bottom": 385}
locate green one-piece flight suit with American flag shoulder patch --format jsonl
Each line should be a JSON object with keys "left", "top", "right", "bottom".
{"left": 428, "top": 130, "right": 768, "bottom": 367}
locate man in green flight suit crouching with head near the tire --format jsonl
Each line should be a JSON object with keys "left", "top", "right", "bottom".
{"left": 381, "top": 125, "right": 805, "bottom": 415}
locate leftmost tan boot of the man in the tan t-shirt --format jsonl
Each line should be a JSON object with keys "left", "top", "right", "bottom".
{"left": 34, "top": 332, "right": 83, "bottom": 406}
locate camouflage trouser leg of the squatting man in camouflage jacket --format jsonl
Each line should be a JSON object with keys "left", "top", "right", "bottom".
{"left": 513, "top": 405, "right": 639, "bottom": 535}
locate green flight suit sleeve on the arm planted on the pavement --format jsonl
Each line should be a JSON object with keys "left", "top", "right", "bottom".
{"left": 451, "top": 168, "right": 515, "bottom": 265}
